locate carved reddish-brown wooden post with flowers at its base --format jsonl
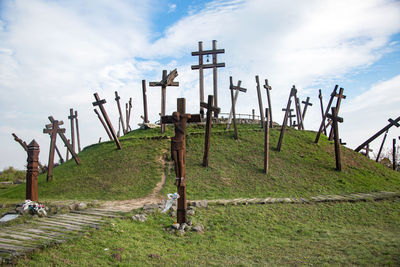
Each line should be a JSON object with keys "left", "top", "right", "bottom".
{"left": 26, "top": 140, "right": 40, "bottom": 202}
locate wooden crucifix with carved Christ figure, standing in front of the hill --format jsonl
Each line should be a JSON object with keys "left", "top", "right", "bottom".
{"left": 161, "top": 98, "right": 201, "bottom": 224}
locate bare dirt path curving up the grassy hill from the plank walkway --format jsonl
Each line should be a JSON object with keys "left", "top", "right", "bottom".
{"left": 99, "top": 150, "right": 172, "bottom": 211}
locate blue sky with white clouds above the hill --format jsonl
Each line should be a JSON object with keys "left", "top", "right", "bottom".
{"left": 0, "top": 0, "right": 400, "bottom": 170}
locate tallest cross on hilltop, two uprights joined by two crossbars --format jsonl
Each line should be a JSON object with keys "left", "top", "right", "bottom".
{"left": 191, "top": 40, "right": 225, "bottom": 117}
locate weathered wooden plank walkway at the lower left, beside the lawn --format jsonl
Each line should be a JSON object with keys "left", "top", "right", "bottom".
{"left": 0, "top": 209, "right": 123, "bottom": 264}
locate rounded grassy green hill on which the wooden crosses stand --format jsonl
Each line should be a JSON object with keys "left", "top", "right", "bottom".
{"left": 0, "top": 125, "right": 400, "bottom": 202}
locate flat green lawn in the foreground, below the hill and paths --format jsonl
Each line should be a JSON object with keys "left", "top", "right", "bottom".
{"left": 14, "top": 199, "right": 400, "bottom": 266}
